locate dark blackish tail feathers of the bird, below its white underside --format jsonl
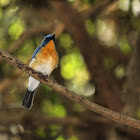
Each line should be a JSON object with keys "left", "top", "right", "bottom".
{"left": 22, "top": 89, "right": 35, "bottom": 109}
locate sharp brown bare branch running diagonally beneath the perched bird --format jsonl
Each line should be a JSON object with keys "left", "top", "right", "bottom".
{"left": 0, "top": 48, "right": 140, "bottom": 129}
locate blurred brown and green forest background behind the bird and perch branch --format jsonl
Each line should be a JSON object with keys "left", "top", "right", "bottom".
{"left": 0, "top": 0, "right": 140, "bottom": 140}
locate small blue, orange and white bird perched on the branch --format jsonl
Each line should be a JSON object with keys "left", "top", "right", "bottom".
{"left": 22, "top": 34, "right": 59, "bottom": 109}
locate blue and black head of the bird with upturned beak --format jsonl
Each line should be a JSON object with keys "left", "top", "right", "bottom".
{"left": 40, "top": 34, "right": 55, "bottom": 47}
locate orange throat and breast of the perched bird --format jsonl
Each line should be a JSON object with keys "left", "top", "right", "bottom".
{"left": 36, "top": 40, "right": 58, "bottom": 68}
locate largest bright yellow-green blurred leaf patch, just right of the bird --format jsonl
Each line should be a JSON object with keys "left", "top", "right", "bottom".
{"left": 60, "top": 52, "right": 90, "bottom": 86}
